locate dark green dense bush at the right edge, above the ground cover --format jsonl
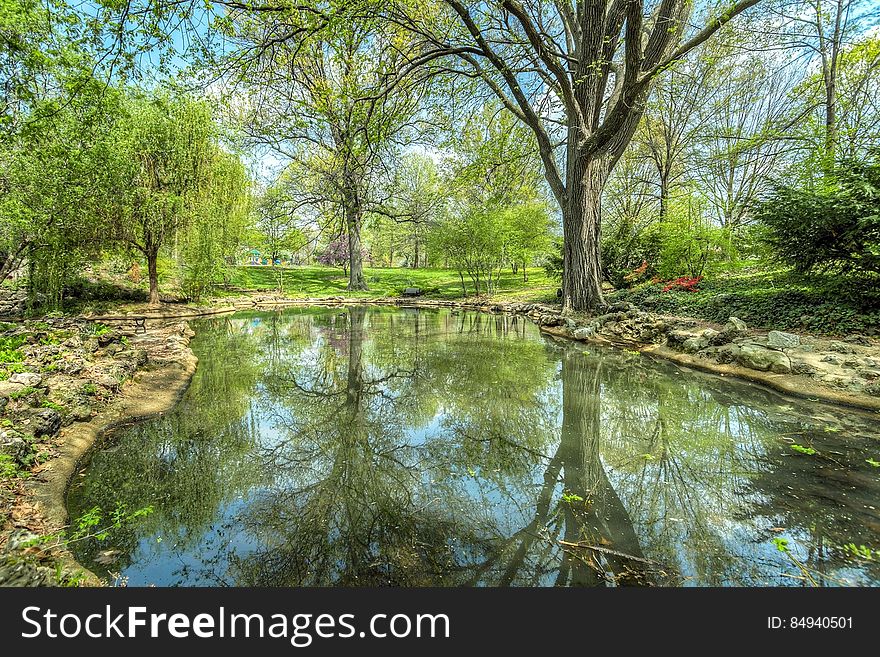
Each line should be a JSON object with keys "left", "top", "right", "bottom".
{"left": 754, "top": 152, "right": 880, "bottom": 274}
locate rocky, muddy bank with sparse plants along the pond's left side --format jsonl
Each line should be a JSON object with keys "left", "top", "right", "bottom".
{"left": 0, "top": 319, "right": 196, "bottom": 586}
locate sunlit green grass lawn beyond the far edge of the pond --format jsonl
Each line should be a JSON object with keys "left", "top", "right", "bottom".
{"left": 230, "top": 266, "right": 559, "bottom": 301}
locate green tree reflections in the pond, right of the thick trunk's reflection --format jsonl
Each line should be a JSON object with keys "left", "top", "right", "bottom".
{"left": 603, "top": 346, "right": 878, "bottom": 585}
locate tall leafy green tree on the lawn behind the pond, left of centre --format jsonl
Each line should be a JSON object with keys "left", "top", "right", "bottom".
{"left": 213, "top": 2, "right": 424, "bottom": 290}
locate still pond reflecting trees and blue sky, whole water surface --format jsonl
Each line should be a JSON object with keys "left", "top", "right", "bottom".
{"left": 68, "top": 306, "right": 880, "bottom": 586}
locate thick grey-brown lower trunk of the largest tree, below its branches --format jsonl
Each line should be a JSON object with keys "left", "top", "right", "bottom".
{"left": 562, "top": 155, "right": 610, "bottom": 311}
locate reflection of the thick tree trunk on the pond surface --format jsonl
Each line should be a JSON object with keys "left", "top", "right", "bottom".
{"left": 559, "top": 351, "right": 645, "bottom": 586}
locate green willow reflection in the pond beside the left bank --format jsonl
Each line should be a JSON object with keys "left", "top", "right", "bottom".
{"left": 68, "top": 318, "right": 266, "bottom": 572}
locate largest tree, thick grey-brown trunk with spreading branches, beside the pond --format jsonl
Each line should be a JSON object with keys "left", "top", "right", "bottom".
{"left": 389, "top": 0, "right": 759, "bottom": 310}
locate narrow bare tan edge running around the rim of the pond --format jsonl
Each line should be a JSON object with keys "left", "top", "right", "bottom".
{"left": 8, "top": 297, "right": 880, "bottom": 586}
